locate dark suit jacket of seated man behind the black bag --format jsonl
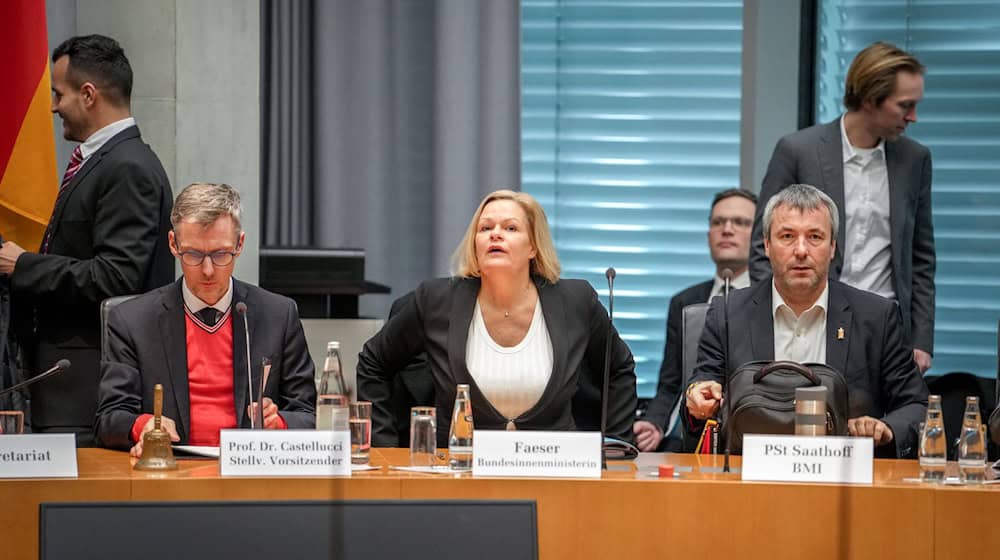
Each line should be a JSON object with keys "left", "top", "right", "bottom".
{"left": 692, "top": 277, "right": 927, "bottom": 458}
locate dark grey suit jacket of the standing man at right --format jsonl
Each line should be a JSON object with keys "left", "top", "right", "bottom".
{"left": 750, "top": 118, "right": 936, "bottom": 353}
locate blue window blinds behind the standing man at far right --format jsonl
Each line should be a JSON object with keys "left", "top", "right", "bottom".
{"left": 816, "top": 0, "right": 1000, "bottom": 376}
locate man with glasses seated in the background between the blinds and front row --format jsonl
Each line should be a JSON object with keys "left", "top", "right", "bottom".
{"left": 632, "top": 189, "right": 757, "bottom": 451}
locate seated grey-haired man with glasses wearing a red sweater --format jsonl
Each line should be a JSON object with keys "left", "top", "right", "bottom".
{"left": 96, "top": 183, "right": 316, "bottom": 456}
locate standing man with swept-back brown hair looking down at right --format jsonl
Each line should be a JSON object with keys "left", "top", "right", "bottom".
{"left": 750, "top": 43, "right": 936, "bottom": 372}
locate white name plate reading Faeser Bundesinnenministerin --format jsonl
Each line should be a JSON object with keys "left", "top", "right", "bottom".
{"left": 472, "top": 430, "right": 601, "bottom": 478}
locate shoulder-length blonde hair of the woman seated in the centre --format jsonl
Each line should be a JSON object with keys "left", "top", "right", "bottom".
{"left": 451, "top": 190, "right": 560, "bottom": 283}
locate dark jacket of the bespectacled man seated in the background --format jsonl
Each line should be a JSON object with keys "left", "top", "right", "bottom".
{"left": 643, "top": 280, "right": 715, "bottom": 430}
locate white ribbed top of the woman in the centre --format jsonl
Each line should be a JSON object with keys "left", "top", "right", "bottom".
{"left": 465, "top": 301, "right": 552, "bottom": 422}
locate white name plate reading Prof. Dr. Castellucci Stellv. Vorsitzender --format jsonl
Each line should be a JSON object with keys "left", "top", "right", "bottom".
{"left": 219, "top": 430, "right": 351, "bottom": 476}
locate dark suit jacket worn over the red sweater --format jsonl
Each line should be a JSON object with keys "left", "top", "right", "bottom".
{"left": 95, "top": 279, "right": 316, "bottom": 449}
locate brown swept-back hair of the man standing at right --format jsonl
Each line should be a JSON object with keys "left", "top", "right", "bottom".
{"left": 844, "top": 41, "right": 924, "bottom": 111}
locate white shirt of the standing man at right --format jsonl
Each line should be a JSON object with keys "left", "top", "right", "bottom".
{"left": 840, "top": 113, "right": 896, "bottom": 299}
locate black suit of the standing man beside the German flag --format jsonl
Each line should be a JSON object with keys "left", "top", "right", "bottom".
{"left": 11, "top": 127, "right": 174, "bottom": 431}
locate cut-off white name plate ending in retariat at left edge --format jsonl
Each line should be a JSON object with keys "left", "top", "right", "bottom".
{"left": 0, "top": 434, "right": 77, "bottom": 478}
